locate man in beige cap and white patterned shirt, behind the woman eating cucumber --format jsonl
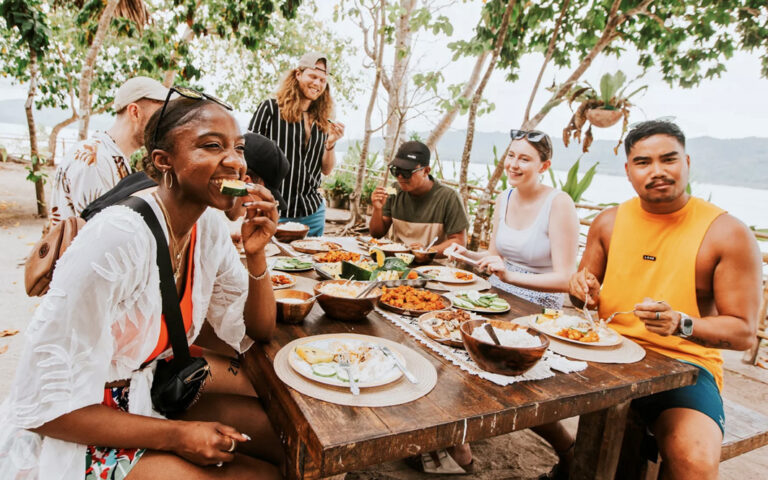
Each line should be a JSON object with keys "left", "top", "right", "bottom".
{"left": 48, "top": 77, "right": 168, "bottom": 228}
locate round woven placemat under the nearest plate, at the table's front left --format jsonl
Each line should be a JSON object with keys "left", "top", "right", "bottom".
{"left": 274, "top": 333, "right": 437, "bottom": 407}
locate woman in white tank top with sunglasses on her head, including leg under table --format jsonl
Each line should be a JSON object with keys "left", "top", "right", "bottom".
{"left": 445, "top": 130, "right": 579, "bottom": 477}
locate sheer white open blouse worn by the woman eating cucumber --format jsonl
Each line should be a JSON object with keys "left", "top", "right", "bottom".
{"left": 0, "top": 196, "right": 253, "bottom": 480}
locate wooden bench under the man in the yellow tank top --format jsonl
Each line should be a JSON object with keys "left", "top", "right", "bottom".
{"left": 616, "top": 399, "right": 768, "bottom": 480}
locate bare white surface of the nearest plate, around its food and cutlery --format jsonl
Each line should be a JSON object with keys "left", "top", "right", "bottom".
{"left": 288, "top": 338, "right": 405, "bottom": 388}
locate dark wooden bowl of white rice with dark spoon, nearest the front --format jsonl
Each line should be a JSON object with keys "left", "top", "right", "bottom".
{"left": 459, "top": 319, "right": 549, "bottom": 375}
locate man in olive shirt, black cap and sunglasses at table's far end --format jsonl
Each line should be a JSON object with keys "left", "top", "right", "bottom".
{"left": 369, "top": 141, "right": 469, "bottom": 253}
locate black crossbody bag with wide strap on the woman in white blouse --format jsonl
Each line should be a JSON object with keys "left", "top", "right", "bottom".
{"left": 124, "top": 197, "right": 210, "bottom": 417}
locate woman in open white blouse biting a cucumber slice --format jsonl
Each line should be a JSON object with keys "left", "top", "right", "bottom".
{"left": 0, "top": 96, "right": 281, "bottom": 480}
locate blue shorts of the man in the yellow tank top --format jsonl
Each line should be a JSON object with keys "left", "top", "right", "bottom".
{"left": 632, "top": 362, "right": 725, "bottom": 434}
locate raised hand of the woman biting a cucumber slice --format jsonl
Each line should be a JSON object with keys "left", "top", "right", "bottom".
{"left": 240, "top": 185, "right": 279, "bottom": 255}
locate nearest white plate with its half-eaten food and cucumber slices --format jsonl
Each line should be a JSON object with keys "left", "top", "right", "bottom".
{"left": 288, "top": 337, "right": 405, "bottom": 388}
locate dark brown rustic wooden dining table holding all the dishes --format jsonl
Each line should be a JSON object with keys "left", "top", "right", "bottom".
{"left": 244, "top": 274, "right": 696, "bottom": 479}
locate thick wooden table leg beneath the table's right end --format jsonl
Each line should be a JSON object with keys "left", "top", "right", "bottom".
{"left": 570, "top": 401, "right": 630, "bottom": 480}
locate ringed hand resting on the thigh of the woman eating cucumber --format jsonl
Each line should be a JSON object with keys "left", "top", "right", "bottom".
{"left": 172, "top": 421, "right": 250, "bottom": 465}
